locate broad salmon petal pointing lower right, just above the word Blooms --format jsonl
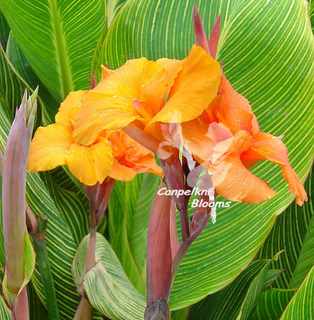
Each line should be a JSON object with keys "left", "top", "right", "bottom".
{"left": 209, "top": 156, "right": 275, "bottom": 203}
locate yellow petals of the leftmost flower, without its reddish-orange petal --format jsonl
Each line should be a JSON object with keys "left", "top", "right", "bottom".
{"left": 28, "top": 91, "right": 113, "bottom": 186}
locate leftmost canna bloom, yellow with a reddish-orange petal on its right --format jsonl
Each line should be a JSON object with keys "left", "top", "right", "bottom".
{"left": 28, "top": 91, "right": 161, "bottom": 186}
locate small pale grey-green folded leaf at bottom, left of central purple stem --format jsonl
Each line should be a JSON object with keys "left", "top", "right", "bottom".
{"left": 73, "top": 234, "right": 145, "bottom": 320}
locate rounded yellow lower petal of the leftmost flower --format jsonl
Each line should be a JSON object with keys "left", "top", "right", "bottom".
{"left": 66, "top": 139, "right": 113, "bottom": 186}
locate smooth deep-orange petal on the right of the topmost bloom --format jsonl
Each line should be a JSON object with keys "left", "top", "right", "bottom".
{"left": 152, "top": 46, "right": 221, "bottom": 123}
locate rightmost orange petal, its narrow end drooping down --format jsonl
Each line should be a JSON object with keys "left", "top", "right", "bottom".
{"left": 243, "top": 132, "right": 307, "bottom": 205}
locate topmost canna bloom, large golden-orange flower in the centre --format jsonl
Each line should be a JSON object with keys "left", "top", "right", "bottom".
{"left": 74, "top": 46, "right": 221, "bottom": 145}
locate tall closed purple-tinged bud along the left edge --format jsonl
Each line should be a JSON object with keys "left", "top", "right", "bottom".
{"left": 2, "top": 92, "right": 37, "bottom": 306}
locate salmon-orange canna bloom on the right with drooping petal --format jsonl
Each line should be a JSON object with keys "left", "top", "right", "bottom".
{"left": 183, "top": 76, "right": 307, "bottom": 205}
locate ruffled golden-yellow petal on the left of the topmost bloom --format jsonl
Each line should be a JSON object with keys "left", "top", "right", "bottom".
{"left": 74, "top": 58, "right": 161, "bottom": 145}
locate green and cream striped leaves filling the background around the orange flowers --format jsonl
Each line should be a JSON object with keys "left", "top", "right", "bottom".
{"left": 0, "top": 0, "right": 314, "bottom": 320}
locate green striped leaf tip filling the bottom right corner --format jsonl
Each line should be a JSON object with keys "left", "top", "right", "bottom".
{"left": 280, "top": 267, "right": 314, "bottom": 320}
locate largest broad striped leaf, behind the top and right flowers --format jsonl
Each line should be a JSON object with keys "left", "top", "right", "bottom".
{"left": 90, "top": 0, "right": 314, "bottom": 309}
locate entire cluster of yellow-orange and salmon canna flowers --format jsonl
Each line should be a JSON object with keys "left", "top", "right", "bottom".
{"left": 29, "top": 45, "right": 307, "bottom": 205}
